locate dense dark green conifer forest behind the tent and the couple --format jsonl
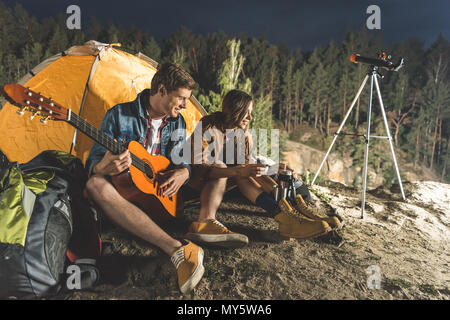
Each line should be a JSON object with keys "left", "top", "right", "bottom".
{"left": 0, "top": 2, "right": 450, "bottom": 181}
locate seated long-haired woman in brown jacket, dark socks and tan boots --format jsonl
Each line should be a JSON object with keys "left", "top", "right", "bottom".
{"left": 187, "top": 90, "right": 341, "bottom": 239}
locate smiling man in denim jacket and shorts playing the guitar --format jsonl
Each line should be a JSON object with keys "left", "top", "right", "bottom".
{"left": 86, "top": 63, "right": 204, "bottom": 293}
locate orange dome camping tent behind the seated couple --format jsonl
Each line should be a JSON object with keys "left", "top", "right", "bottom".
{"left": 0, "top": 40, "right": 207, "bottom": 163}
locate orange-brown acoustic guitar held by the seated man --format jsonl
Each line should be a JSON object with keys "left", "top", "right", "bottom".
{"left": 1, "top": 84, "right": 183, "bottom": 220}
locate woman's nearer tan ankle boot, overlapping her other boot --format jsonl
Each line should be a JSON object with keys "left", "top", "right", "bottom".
{"left": 275, "top": 198, "right": 331, "bottom": 239}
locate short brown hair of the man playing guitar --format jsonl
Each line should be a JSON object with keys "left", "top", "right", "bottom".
{"left": 150, "top": 62, "right": 195, "bottom": 96}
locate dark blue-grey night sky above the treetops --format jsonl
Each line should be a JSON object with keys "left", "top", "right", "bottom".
{"left": 0, "top": 0, "right": 450, "bottom": 50}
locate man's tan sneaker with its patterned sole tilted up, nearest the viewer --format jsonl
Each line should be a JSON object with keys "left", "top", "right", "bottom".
{"left": 170, "top": 241, "right": 205, "bottom": 294}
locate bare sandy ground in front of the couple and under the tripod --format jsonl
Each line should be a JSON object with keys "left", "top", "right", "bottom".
{"left": 72, "top": 182, "right": 450, "bottom": 300}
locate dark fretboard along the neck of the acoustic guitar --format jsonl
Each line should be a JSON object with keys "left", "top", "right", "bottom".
{"left": 68, "top": 112, "right": 153, "bottom": 178}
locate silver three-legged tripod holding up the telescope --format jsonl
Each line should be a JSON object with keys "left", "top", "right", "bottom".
{"left": 311, "top": 66, "right": 405, "bottom": 219}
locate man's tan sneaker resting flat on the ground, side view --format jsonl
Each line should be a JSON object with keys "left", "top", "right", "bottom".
{"left": 185, "top": 219, "right": 248, "bottom": 248}
